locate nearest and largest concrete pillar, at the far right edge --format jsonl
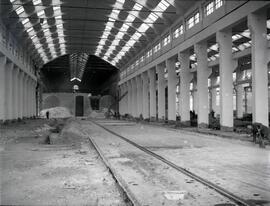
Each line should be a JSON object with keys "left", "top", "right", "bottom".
{"left": 248, "top": 10, "right": 269, "bottom": 126}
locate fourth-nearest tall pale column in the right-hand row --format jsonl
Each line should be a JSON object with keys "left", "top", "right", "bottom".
{"left": 178, "top": 51, "right": 194, "bottom": 122}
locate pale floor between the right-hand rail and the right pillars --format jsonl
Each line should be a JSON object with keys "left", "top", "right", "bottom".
{"left": 89, "top": 121, "right": 270, "bottom": 205}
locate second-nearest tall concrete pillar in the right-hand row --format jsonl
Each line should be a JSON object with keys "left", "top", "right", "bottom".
{"left": 216, "top": 29, "right": 234, "bottom": 131}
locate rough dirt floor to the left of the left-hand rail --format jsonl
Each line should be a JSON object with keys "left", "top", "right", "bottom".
{"left": 0, "top": 119, "right": 127, "bottom": 205}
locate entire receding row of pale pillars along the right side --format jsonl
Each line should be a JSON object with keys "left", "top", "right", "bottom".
{"left": 120, "top": 12, "right": 268, "bottom": 129}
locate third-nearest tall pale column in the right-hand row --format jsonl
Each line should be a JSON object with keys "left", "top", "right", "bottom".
{"left": 194, "top": 42, "right": 211, "bottom": 127}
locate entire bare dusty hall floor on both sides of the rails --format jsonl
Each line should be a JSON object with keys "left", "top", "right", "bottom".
{"left": 0, "top": 120, "right": 270, "bottom": 206}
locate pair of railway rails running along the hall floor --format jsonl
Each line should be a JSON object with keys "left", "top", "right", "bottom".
{"left": 89, "top": 120, "right": 256, "bottom": 206}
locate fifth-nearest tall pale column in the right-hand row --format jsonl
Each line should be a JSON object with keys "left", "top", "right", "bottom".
{"left": 166, "top": 58, "right": 177, "bottom": 121}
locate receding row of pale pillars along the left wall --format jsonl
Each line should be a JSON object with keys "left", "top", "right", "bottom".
{"left": 0, "top": 56, "right": 36, "bottom": 122}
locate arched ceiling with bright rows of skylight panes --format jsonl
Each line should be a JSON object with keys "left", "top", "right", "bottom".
{"left": 1, "top": 0, "right": 196, "bottom": 68}
